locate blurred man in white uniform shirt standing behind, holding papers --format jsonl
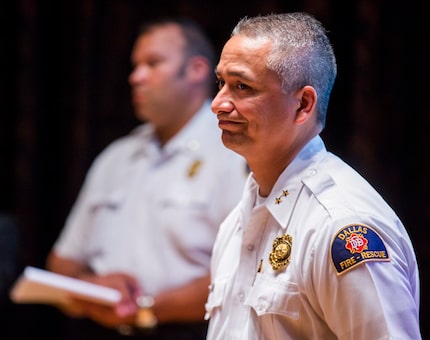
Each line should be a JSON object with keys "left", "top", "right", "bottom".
{"left": 47, "top": 19, "right": 247, "bottom": 340}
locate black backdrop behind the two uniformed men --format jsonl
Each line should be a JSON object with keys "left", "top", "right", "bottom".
{"left": 0, "top": 0, "right": 430, "bottom": 340}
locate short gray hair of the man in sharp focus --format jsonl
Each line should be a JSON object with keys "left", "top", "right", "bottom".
{"left": 231, "top": 12, "right": 337, "bottom": 127}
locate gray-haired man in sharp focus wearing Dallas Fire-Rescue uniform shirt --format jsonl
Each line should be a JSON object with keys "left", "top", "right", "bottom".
{"left": 206, "top": 13, "right": 421, "bottom": 340}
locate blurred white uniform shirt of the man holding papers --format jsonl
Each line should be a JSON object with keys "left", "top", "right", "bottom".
{"left": 54, "top": 102, "right": 247, "bottom": 295}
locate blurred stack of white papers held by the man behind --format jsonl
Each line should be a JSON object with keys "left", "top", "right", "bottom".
{"left": 10, "top": 266, "right": 121, "bottom": 305}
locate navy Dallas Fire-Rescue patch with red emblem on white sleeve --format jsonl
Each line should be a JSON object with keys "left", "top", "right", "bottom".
{"left": 331, "top": 224, "right": 390, "bottom": 275}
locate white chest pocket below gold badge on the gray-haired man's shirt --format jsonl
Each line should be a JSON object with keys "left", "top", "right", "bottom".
{"left": 245, "top": 273, "right": 300, "bottom": 320}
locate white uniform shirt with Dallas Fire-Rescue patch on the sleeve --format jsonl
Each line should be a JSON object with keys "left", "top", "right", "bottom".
{"left": 206, "top": 137, "right": 420, "bottom": 340}
